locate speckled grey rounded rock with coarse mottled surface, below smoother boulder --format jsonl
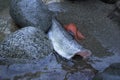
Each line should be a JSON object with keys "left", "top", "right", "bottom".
{"left": 0, "top": 26, "right": 52, "bottom": 59}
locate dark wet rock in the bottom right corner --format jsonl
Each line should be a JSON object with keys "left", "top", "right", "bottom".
{"left": 93, "top": 63, "right": 120, "bottom": 80}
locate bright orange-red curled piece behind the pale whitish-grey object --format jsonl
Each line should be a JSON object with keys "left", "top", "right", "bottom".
{"left": 64, "top": 23, "right": 85, "bottom": 41}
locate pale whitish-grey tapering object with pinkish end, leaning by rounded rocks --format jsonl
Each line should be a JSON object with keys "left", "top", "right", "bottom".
{"left": 48, "top": 18, "right": 92, "bottom": 59}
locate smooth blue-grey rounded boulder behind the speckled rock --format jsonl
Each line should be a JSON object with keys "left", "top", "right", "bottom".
{"left": 10, "top": 0, "right": 52, "bottom": 32}
